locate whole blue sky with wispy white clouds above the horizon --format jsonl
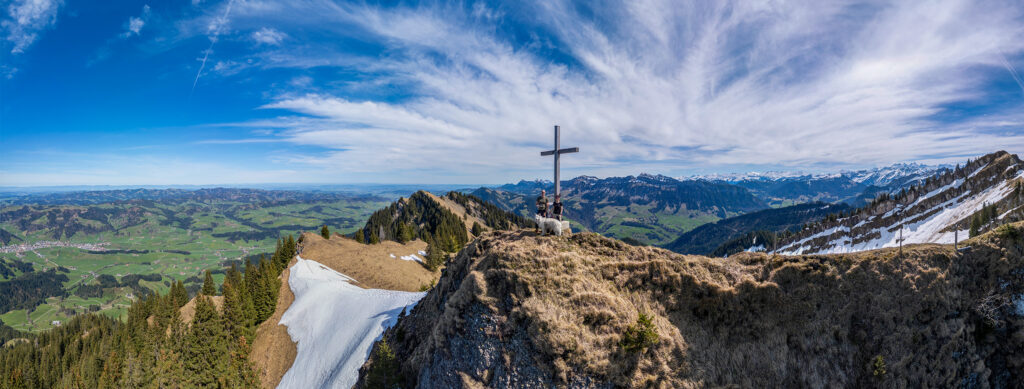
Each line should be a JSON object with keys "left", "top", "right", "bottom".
{"left": 6, "top": 0, "right": 1024, "bottom": 186}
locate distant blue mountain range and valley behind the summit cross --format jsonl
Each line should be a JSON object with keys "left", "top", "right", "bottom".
{"left": 463, "top": 159, "right": 949, "bottom": 244}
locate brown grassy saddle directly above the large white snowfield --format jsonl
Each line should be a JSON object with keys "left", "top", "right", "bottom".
{"left": 300, "top": 232, "right": 440, "bottom": 292}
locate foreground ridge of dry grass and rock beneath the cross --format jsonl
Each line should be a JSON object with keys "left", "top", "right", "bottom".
{"left": 358, "top": 228, "right": 1024, "bottom": 388}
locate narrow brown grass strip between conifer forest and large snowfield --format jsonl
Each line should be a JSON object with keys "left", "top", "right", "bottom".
{"left": 249, "top": 259, "right": 298, "bottom": 389}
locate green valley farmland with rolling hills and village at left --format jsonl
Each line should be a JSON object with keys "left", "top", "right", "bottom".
{"left": 0, "top": 189, "right": 389, "bottom": 332}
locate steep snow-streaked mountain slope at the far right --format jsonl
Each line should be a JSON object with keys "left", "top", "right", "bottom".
{"left": 777, "top": 152, "right": 1024, "bottom": 254}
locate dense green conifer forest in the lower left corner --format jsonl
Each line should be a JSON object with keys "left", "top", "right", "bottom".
{"left": 0, "top": 236, "right": 296, "bottom": 388}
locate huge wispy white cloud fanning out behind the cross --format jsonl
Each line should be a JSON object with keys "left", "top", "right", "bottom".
{"left": 197, "top": 0, "right": 1024, "bottom": 181}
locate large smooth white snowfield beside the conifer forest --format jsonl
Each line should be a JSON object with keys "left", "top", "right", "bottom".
{"left": 278, "top": 257, "right": 426, "bottom": 389}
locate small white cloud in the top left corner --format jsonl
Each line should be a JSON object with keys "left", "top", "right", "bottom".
{"left": 0, "top": 0, "right": 63, "bottom": 54}
